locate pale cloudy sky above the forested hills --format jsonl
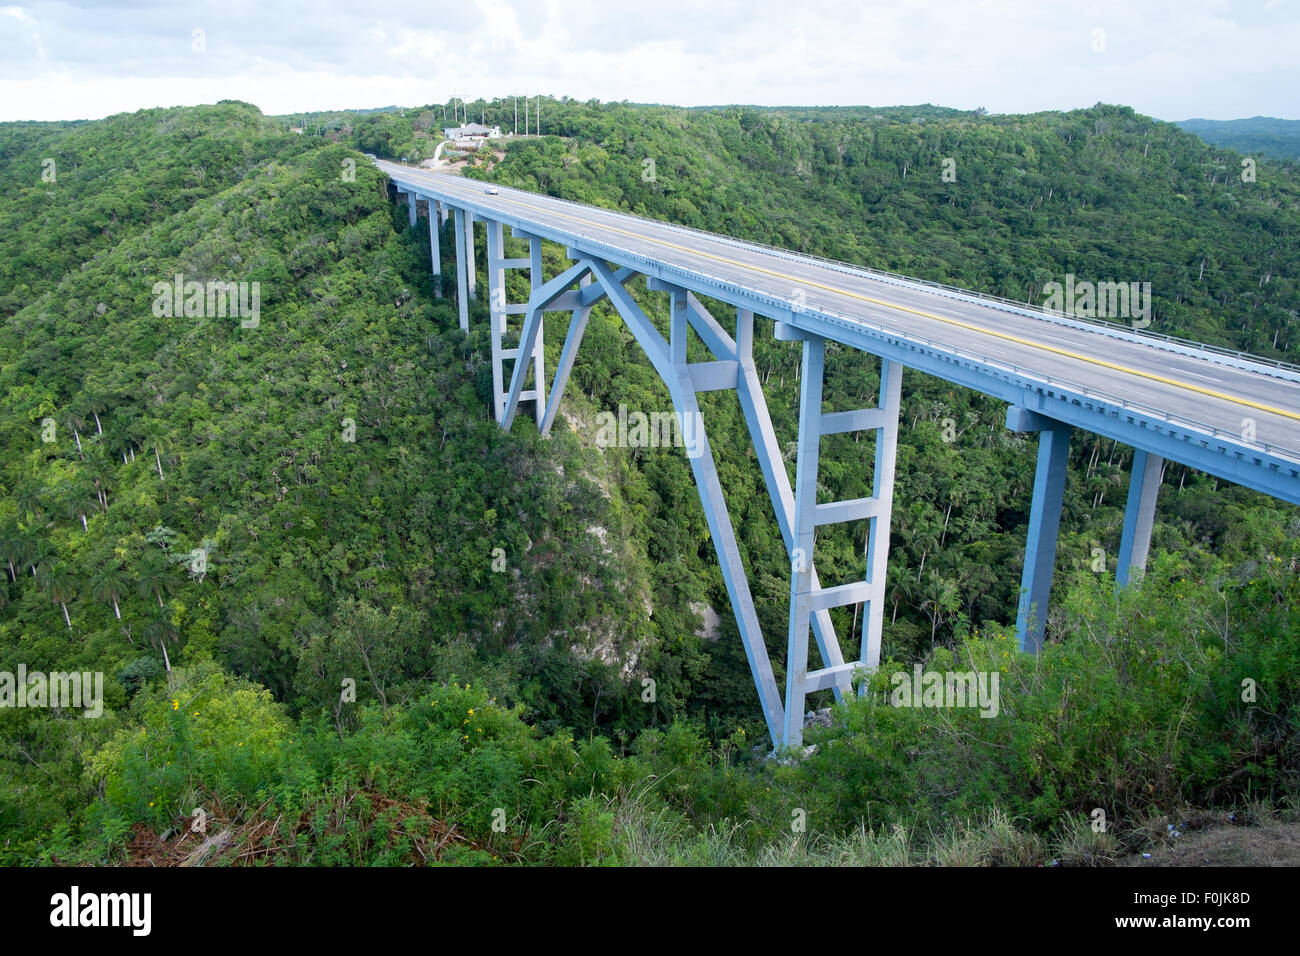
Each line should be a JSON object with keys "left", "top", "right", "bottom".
{"left": 0, "top": 0, "right": 1300, "bottom": 120}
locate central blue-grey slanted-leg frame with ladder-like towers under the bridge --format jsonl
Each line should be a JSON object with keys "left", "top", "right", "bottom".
{"left": 488, "top": 235, "right": 902, "bottom": 747}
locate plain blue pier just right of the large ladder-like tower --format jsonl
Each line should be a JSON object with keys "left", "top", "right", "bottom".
{"left": 1006, "top": 405, "right": 1073, "bottom": 652}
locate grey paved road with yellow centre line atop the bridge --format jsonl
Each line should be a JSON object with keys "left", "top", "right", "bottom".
{"left": 377, "top": 160, "right": 1300, "bottom": 457}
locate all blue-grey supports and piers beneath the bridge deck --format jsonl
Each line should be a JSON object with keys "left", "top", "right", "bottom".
{"left": 384, "top": 175, "right": 1279, "bottom": 748}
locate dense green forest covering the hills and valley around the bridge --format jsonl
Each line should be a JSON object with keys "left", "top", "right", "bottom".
{"left": 0, "top": 99, "right": 1300, "bottom": 865}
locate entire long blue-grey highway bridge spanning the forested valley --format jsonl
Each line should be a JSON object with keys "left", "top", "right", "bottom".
{"left": 376, "top": 160, "right": 1300, "bottom": 747}
